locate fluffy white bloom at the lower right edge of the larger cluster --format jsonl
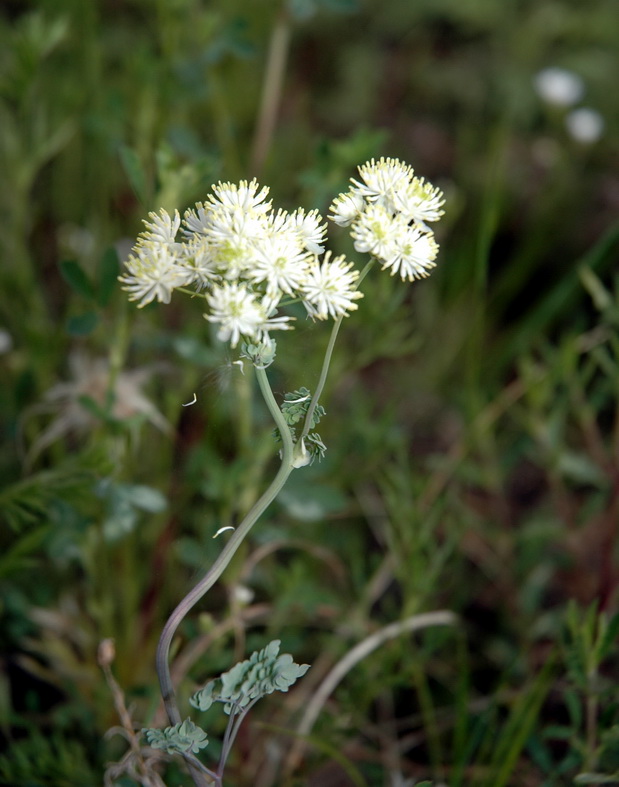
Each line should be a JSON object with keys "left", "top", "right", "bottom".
{"left": 302, "top": 251, "right": 363, "bottom": 320}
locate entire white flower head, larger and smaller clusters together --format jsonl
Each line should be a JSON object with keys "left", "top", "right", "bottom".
{"left": 119, "top": 158, "right": 444, "bottom": 347}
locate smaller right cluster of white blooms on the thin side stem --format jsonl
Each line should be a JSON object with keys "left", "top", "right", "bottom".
{"left": 329, "top": 158, "right": 445, "bottom": 281}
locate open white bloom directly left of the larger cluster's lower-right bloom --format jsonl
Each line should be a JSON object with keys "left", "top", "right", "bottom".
{"left": 246, "top": 233, "right": 310, "bottom": 298}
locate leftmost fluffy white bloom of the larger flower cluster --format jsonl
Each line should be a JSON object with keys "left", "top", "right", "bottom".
{"left": 118, "top": 243, "right": 192, "bottom": 308}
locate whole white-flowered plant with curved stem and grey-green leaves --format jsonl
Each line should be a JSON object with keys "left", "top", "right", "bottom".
{"left": 120, "top": 158, "right": 444, "bottom": 785}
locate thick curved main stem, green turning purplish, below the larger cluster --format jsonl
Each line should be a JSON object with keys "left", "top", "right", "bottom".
{"left": 156, "top": 368, "right": 293, "bottom": 784}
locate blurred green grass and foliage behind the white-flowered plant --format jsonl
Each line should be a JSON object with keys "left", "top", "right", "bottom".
{"left": 0, "top": 0, "right": 619, "bottom": 787}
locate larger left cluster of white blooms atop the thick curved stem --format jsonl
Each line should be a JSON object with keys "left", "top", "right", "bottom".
{"left": 120, "top": 180, "right": 362, "bottom": 347}
